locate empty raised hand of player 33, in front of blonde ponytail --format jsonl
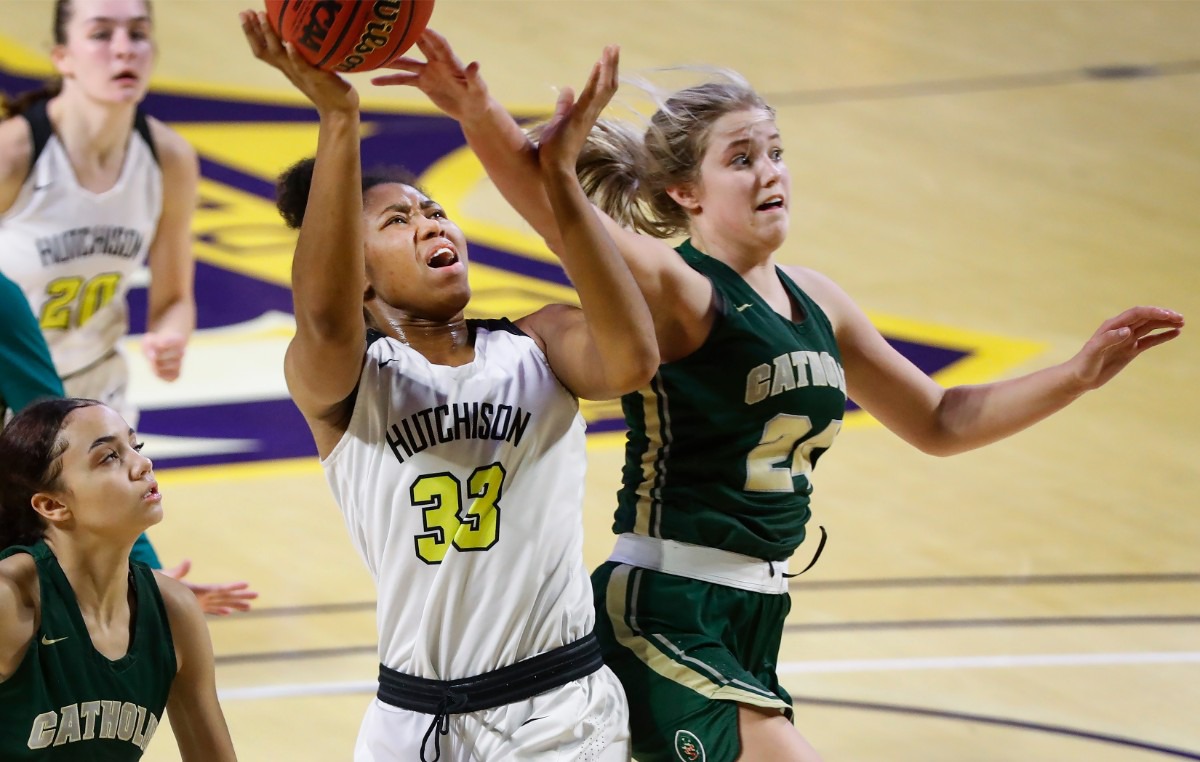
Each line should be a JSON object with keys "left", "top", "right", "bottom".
{"left": 538, "top": 46, "right": 620, "bottom": 176}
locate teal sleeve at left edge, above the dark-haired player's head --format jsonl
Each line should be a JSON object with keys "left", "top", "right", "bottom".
{"left": 0, "top": 274, "right": 62, "bottom": 424}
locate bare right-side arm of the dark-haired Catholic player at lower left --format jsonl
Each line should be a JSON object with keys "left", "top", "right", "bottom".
{"left": 155, "top": 575, "right": 236, "bottom": 762}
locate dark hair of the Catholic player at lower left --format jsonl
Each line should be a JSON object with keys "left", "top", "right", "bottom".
{"left": 0, "top": 397, "right": 101, "bottom": 548}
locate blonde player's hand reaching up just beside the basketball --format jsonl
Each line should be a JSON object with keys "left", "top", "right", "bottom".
{"left": 371, "top": 29, "right": 488, "bottom": 122}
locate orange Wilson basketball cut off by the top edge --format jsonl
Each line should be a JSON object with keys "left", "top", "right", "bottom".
{"left": 266, "top": 0, "right": 433, "bottom": 73}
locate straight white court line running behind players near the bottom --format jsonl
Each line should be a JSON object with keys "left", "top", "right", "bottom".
{"left": 217, "top": 650, "right": 1200, "bottom": 701}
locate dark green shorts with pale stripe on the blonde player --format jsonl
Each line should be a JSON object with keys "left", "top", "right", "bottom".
{"left": 592, "top": 562, "right": 792, "bottom": 762}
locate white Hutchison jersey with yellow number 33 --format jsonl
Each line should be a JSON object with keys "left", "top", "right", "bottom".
{"left": 323, "top": 320, "right": 595, "bottom": 680}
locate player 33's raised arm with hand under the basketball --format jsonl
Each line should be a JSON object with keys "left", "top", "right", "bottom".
{"left": 241, "top": 11, "right": 365, "bottom": 457}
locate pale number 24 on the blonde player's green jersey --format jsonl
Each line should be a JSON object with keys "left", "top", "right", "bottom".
{"left": 745, "top": 413, "right": 841, "bottom": 492}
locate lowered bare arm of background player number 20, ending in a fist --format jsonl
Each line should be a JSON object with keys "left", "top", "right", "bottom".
{"left": 142, "top": 119, "right": 200, "bottom": 380}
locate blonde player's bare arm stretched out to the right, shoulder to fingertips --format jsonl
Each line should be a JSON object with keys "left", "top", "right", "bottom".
{"left": 788, "top": 268, "right": 1183, "bottom": 455}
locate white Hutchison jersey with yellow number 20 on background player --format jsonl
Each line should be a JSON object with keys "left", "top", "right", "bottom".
{"left": 0, "top": 101, "right": 162, "bottom": 378}
